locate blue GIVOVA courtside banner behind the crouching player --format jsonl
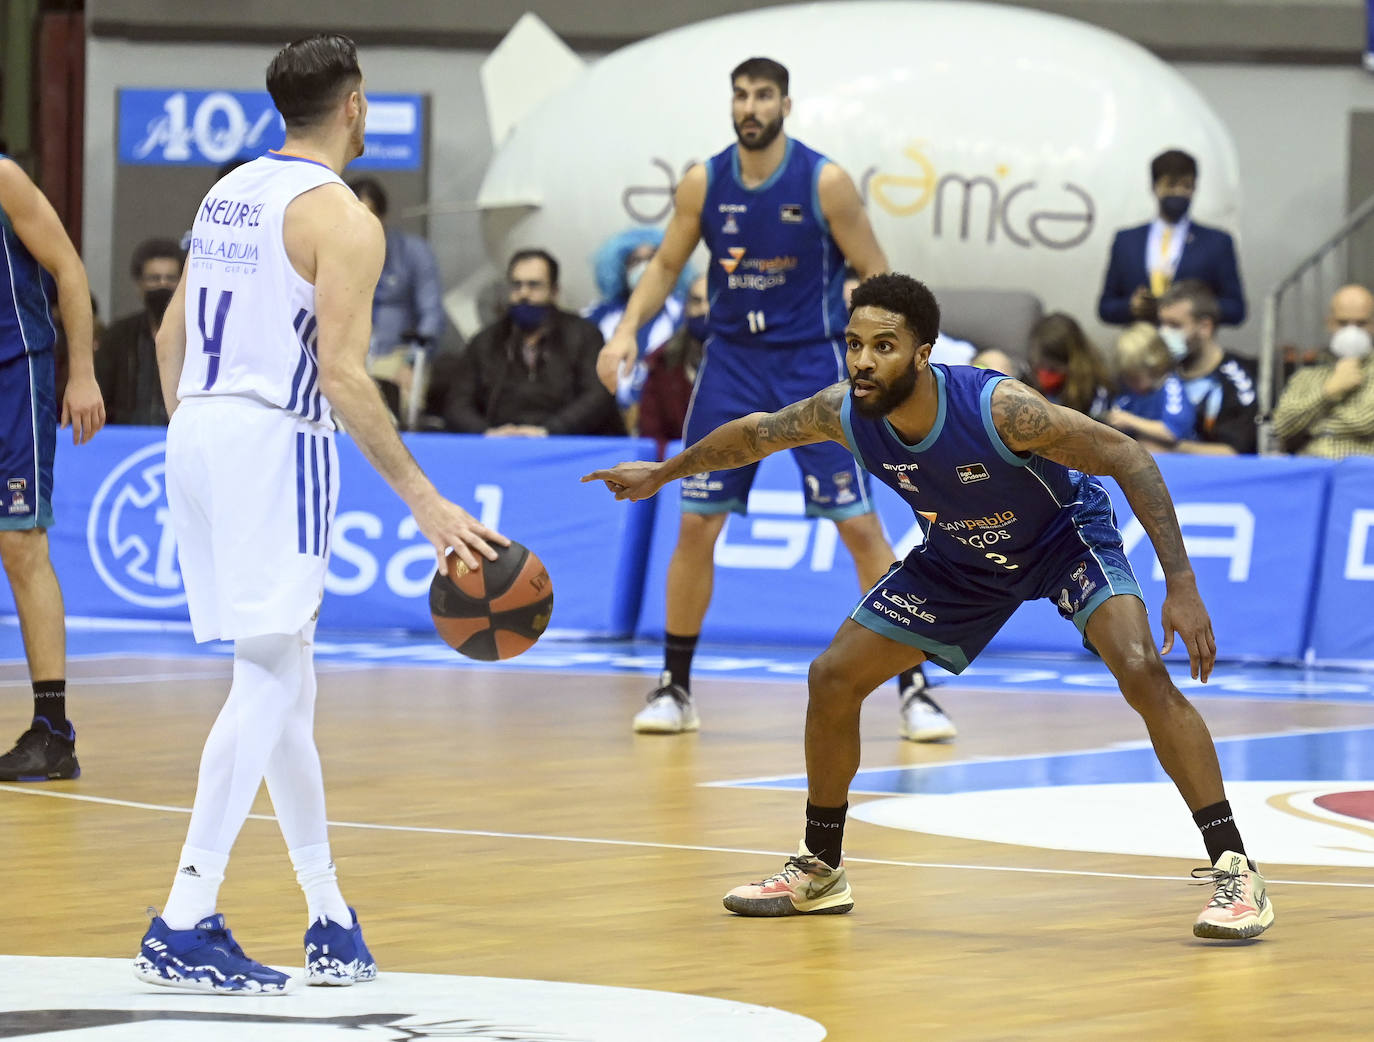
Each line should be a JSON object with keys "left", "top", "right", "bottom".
{"left": 639, "top": 455, "right": 1331, "bottom": 658}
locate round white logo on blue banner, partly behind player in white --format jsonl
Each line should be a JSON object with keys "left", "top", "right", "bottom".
{"left": 87, "top": 441, "right": 185, "bottom": 608}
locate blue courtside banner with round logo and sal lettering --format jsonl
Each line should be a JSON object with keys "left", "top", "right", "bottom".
{"left": 0, "top": 428, "right": 654, "bottom": 636}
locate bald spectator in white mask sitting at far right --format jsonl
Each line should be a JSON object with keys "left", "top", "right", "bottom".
{"left": 1274, "top": 286, "right": 1374, "bottom": 459}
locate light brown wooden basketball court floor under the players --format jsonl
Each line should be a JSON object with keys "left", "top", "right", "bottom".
{"left": 0, "top": 657, "right": 1374, "bottom": 1042}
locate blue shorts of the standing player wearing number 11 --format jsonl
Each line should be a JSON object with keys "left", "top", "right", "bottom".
{"left": 682, "top": 337, "right": 872, "bottom": 521}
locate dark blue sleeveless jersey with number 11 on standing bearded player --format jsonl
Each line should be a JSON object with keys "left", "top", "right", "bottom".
{"left": 701, "top": 137, "right": 846, "bottom": 346}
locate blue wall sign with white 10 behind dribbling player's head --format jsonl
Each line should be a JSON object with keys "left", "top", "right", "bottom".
{"left": 118, "top": 88, "right": 425, "bottom": 170}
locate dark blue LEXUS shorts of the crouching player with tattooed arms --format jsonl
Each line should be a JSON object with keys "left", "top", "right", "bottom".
{"left": 849, "top": 505, "right": 1145, "bottom": 674}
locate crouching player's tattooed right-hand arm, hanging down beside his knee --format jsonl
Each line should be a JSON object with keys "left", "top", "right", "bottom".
{"left": 992, "top": 379, "right": 1216, "bottom": 680}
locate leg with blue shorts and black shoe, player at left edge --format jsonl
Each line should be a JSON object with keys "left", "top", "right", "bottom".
{"left": 0, "top": 355, "right": 81, "bottom": 781}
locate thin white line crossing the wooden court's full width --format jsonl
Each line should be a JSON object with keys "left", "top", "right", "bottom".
{"left": 0, "top": 784, "right": 1374, "bottom": 889}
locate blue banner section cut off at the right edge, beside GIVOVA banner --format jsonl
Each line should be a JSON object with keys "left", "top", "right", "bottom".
{"left": 1311, "top": 458, "right": 1374, "bottom": 661}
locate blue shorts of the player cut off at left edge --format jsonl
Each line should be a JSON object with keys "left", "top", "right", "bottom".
{"left": 0, "top": 351, "right": 58, "bottom": 529}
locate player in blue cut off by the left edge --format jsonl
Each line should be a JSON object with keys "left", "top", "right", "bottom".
{"left": 0, "top": 155, "right": 104, "bottom": 781}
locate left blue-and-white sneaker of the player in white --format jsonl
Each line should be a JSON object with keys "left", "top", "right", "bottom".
{"left": 133, "top": 914, "right": 291, "bottom": 995}
